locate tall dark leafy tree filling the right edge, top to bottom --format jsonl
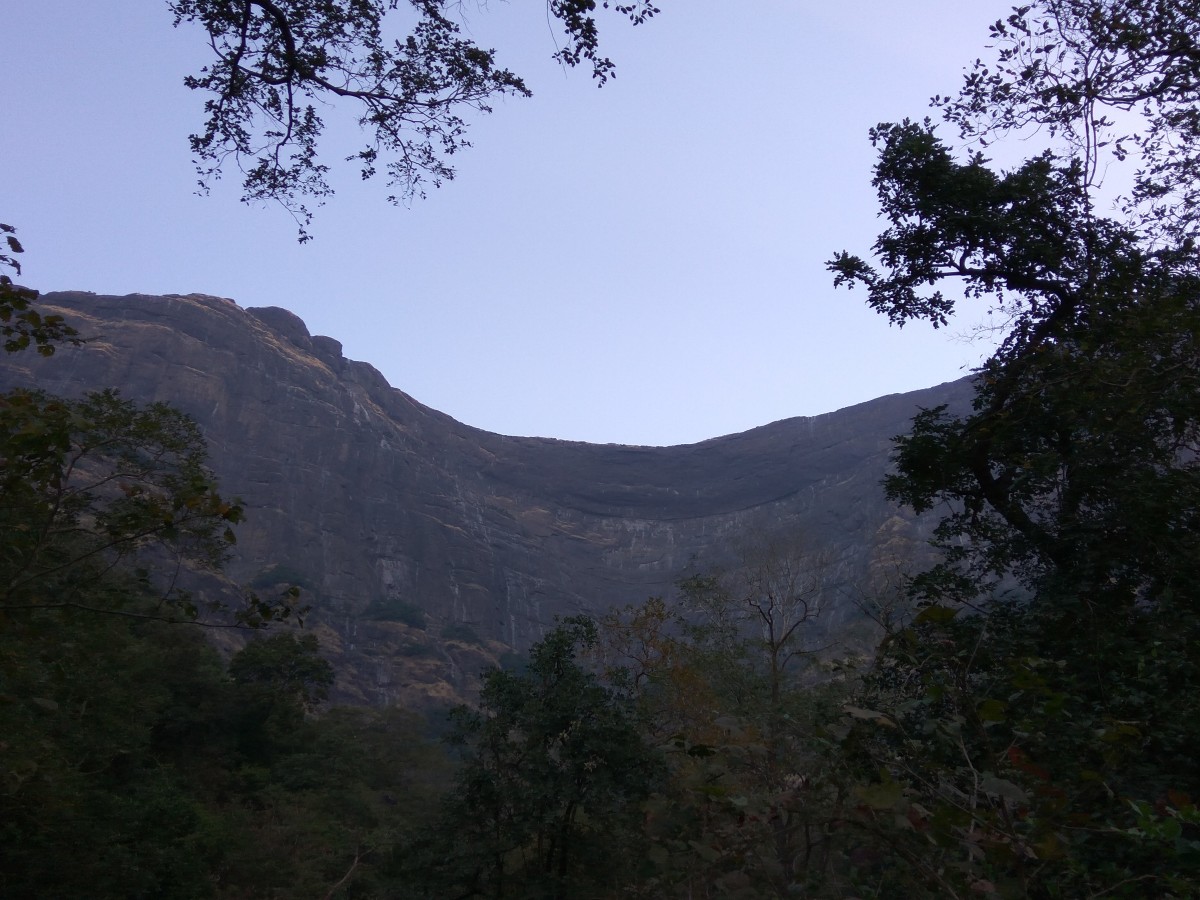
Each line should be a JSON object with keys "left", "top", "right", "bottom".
{"left": 829, "top": 0, "right": 1200, "bottom": 896}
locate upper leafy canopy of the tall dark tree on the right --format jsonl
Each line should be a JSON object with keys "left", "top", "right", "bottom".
{"left": 830, "top": 0, "right": 1200, "bottom": 609}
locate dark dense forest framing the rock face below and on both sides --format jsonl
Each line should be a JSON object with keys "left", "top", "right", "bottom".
{"left": 0, "top": 0, "right": 1200, "bottom": 900}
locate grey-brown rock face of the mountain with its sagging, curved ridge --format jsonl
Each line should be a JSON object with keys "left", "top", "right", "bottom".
{"left": 0, "top": 293, "right": 967, "bottom": 702}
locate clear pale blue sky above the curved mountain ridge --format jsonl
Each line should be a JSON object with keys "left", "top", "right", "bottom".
{"left": 0, "top": 0, "right": 1010, "bottom": 445}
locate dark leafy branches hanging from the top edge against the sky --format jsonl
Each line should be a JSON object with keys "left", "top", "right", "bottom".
{"left": 168, "top": 0, "right": 659, "bottom": 241}
